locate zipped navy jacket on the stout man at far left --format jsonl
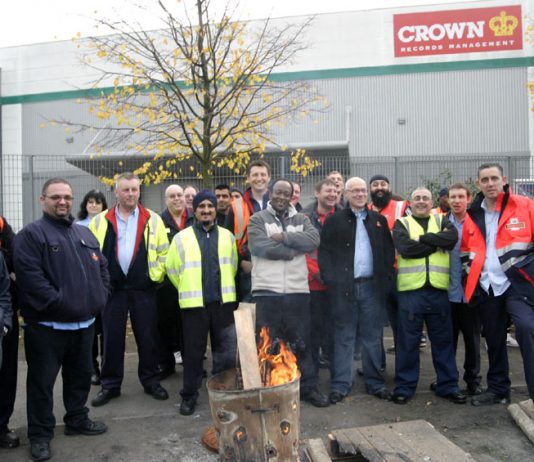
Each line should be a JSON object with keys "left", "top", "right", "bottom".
{"left": 13, "top": 214, "right": 110, "bottom": 322}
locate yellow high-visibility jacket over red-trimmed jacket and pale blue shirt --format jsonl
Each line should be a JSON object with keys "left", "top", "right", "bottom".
{"left": 89, "top": 209, "right": 169, "bottom": 283}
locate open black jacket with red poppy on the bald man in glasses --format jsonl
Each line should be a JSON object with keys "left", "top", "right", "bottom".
{"left": 319, "top": 208, "right": 395, "bottom": 308}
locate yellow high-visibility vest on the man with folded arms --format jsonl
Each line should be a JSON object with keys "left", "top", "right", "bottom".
{"left": 397, "top": 214, "right": 450, "bottom": 292}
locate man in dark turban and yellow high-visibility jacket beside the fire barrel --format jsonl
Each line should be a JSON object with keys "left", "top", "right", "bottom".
{"left": 165, "top": 190, "right": 237, "bottom": 415}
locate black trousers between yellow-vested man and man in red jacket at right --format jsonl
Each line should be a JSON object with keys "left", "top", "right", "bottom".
{"left": 451, "top": 302, "right": 481, "bottom": 386}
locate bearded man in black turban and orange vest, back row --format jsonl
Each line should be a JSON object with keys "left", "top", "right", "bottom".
{"left": 369, "top": 175, "right": 411, "bottom": 351}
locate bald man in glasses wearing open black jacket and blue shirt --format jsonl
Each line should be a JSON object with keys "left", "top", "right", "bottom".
{"left": 319, "top": 177, "right": 395, "bottom": 404}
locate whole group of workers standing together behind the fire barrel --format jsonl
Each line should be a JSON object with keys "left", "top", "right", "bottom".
{"left": 0, "top": 160, "right": 534, "bottom": 461}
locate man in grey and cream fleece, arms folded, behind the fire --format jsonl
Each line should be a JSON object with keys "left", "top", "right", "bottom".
{"left": 248, "top": 179, "right": 328, "bottom": 407}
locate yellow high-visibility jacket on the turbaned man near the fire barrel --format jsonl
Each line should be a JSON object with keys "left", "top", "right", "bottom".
{"left": 165, "top": 226, "right": 237, "bottom": 309}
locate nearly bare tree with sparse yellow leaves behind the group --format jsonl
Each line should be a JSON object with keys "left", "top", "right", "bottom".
{"left": 60, "top": 0, "right": 327, "bottom": 185}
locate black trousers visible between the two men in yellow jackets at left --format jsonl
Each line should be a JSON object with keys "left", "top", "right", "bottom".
{"left": 156, "top": 281, "right": 183, "bottom": 368}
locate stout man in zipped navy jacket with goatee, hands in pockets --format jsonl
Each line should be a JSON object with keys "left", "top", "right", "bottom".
{"left": 13, "top": 178, "right": 110, "bottom": 461}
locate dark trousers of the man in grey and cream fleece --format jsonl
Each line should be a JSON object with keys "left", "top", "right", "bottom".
{"left": 254, "top": 294, "right": 319, "bottom": 394}
